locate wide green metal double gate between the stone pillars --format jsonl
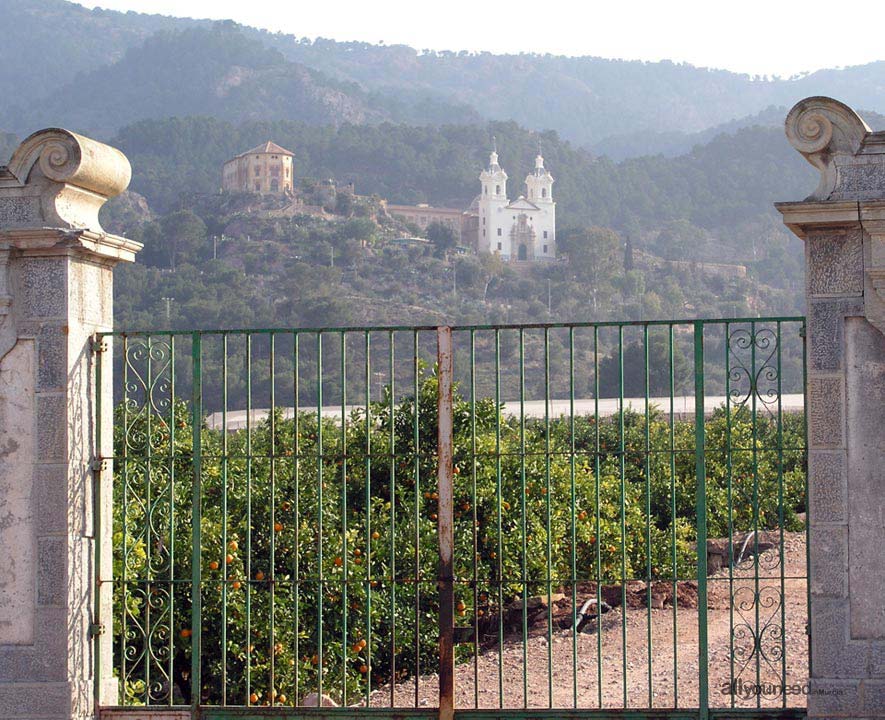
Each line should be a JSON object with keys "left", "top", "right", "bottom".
{"left": 96, "top": 317, "right": 809, "bottom": 720}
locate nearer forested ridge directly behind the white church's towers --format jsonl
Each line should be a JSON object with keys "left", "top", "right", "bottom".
{"left": 107, "top": 118, "right": 814, "bottom": 259}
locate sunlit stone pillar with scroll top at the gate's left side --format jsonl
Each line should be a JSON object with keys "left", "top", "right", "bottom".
{"left": 0, "top": 129, "right": 141, "bottom": 720}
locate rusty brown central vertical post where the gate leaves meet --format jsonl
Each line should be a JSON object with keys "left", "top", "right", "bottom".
{"left": 436, "top": 327, "right": 455, "bottom": 720}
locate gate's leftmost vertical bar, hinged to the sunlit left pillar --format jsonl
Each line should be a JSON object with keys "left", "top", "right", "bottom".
{"left": 92, "top": 335, "right": 104, "bottom": 707}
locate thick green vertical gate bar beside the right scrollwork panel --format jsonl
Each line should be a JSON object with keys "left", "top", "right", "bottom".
{"left": 694, "top": 320, "right": 710, "bottom": 720}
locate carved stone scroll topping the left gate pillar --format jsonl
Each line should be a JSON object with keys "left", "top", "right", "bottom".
{"left": 0, "top": 128, "right": 132, "bottom": 233}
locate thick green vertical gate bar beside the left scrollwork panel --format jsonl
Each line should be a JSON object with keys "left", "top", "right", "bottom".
{"left": 191, "top": 332, "right": 203, "bottom": 710}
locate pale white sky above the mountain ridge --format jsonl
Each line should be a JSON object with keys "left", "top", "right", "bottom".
{"left": 82, "top": 0, "right": 885, "bottom": 76}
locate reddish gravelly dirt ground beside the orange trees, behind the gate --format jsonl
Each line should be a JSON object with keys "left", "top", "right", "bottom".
{"left": 362, "top": 533, "right": 808, "bottom": 708}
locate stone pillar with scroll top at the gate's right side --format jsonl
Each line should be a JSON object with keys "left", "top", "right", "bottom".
{"left": 777, "top": 97, "right": 885, "bottom": 718}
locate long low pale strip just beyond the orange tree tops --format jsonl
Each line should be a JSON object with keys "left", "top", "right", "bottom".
{"left": 206, "top": 393, "right": 805, "bottom": 431}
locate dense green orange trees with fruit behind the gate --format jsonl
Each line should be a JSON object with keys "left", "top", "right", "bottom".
{"left": 114, "top": 375, "right": 805, "bottom": 704}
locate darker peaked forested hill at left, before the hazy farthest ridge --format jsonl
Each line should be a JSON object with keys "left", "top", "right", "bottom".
{"left": 5, "top": 23, "right": 479, "bottom": 137}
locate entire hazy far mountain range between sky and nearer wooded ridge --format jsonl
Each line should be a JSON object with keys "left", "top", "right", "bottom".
{"left": 0, "top": 0, "right": 885, "bottom": 152}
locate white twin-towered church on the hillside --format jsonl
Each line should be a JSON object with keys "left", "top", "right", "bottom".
{"left": 475, "top": 141, "right": 556, "bottom": 262}
